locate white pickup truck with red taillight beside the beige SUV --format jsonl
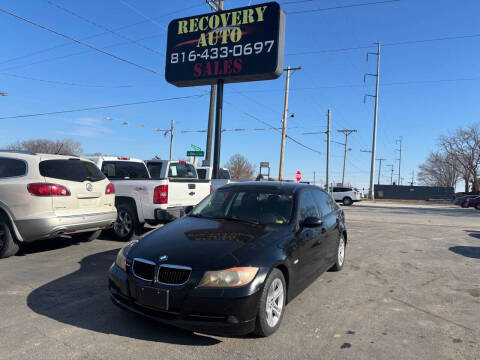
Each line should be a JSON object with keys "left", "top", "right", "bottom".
{"left": 88, "top": 156, "right": 211, "bottom": 240}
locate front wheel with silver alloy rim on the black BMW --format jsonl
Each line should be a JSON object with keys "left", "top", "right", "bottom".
{"left": 255, "top": 269, "right": 287, "bottom": 337}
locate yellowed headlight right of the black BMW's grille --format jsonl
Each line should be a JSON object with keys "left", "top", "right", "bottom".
{"left": 197, "top": 267, "right": 258, "bottom": 288}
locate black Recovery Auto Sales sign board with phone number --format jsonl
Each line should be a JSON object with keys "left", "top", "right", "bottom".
{"left": 165, "top": 2, "right": 285, "bottom": 86}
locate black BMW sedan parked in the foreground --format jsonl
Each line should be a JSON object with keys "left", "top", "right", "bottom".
{"left": 109, "top": 182, "right": 347, "bottom": 336}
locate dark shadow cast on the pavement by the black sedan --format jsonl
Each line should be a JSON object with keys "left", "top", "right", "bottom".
{"left": 27, "top": 249, "right": 220, "bottom": 346}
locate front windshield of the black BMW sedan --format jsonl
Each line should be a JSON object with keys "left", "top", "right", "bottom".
{"left": 190, "top": 188, "right": 293, "bottom": 225}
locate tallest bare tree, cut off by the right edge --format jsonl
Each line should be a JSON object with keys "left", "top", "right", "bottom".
{"left": 439, "top": 123, "right": 480, "bottom": 192}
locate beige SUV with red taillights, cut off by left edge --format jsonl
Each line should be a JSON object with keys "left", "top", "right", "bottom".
{"left": 0, "top": 150, "right": 117, "bottom": 258}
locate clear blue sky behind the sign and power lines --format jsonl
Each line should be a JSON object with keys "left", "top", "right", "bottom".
{"left": 0, "top": 0, "right": 480, "bottom": 188}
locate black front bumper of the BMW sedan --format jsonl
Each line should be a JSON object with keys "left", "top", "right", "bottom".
{"left": 109, "top": 264, "right": 261, "bottom": 336}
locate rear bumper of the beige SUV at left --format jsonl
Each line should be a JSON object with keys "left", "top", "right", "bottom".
{"left": 15, "top": 210, "right": 117, "bottom": 242}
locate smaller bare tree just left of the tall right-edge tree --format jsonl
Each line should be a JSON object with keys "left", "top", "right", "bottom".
{"left": 418, "top": 152, "right": 460, "bottom": 187}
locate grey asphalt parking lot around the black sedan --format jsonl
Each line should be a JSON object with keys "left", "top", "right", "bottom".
{"left": 0, "top": 202, "right": 480, "bottom": 360}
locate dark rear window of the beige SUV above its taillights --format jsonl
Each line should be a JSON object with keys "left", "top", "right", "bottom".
{"left": 39, "top": 159, "right": 105, "bottom": 182}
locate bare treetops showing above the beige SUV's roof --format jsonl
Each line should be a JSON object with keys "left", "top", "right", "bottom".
{"left": 7, "top": 139, "right": 83, "bottom": 155}
